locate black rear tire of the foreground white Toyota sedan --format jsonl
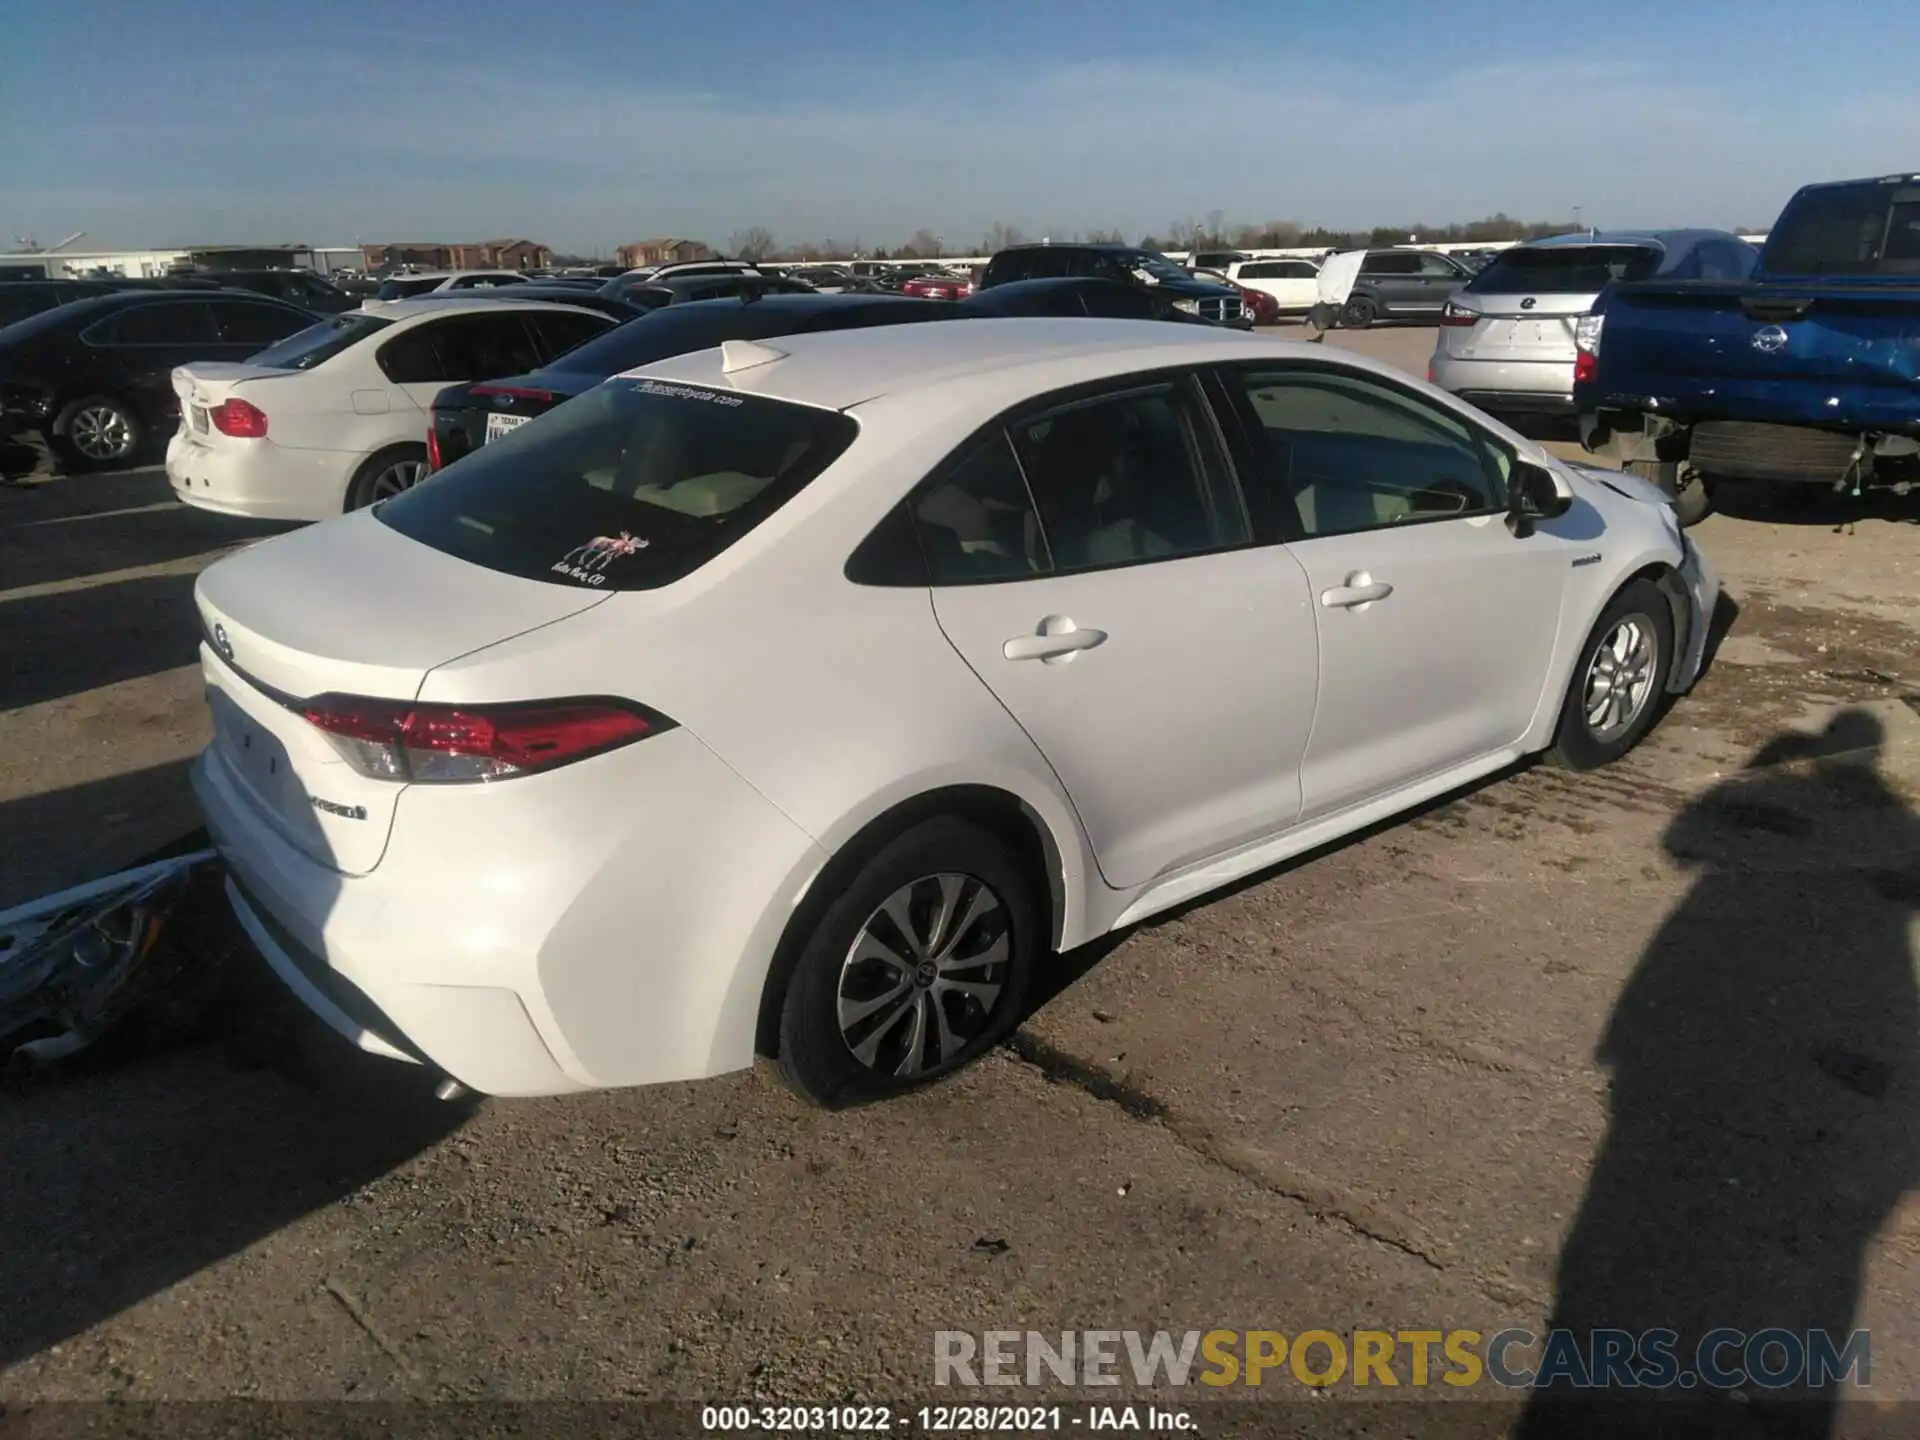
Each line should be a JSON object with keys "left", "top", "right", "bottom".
{"left": 778, "top": 816, "right": 1044, "bottom": 1110}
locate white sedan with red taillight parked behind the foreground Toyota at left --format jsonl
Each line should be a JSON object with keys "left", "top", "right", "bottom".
{"left": 167, "top": 298, "right": 614, "bottom": 520}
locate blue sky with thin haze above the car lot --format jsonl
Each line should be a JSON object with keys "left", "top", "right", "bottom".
{"left": 0, "top": 0, "right": 1920, "bottom": 252}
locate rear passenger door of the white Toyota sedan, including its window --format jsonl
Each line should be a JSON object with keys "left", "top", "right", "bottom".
{"left": 912, "top": 374, "right": 1315, "bottom": 887}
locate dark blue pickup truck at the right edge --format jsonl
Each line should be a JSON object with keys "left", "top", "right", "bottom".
{"left": 1574, "top": 175, "right": 1920, "bottom": 524}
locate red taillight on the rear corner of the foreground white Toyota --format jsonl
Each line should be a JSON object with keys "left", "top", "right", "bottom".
{"left": 301, "top": 695, "right": 674, "bottom": 785}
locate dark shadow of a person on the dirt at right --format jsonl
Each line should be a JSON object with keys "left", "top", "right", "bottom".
{"left": 1515, "top": 710, "right": 1920, "bottom": 1440}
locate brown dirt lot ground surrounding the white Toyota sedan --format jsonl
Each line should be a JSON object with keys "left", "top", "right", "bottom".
{"left": 0, "top": 330, "right": 1920, "bottom": 1434}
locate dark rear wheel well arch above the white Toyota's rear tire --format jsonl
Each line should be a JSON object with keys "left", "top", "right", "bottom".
{"left": 755, "top": 785, "right": 1066, "bottom": 1056}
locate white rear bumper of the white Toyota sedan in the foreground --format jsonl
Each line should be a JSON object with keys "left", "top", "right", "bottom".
{"left": 192, "top": 730, "right": 824, "bottom": 1094}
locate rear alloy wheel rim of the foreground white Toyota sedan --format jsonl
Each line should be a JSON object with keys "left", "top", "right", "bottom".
{"left": 837, "top": 874, "right": 1012, "bottom": 1079}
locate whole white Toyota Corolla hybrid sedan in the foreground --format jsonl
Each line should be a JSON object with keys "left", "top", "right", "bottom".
{"left": 194, "top": 319, "right": 1716, "bottom": 1104}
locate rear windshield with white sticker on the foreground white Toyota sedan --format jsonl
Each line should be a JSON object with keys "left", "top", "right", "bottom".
{"left": 378, "top": 378, "right": 858, "bottom": 589}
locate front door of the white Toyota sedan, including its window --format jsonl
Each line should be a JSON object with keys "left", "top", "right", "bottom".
{"left": 1223, "top": 361, "right": 1574, "bottom": 820}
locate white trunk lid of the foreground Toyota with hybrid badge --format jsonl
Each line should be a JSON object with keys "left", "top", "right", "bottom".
{"left": 194, "top": 511, "right": 607, "bottom": 876}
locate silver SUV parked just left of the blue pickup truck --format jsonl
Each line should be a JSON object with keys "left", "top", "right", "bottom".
{"left": 1427, "top": 230, "right": 1761, "bottom": 415}
